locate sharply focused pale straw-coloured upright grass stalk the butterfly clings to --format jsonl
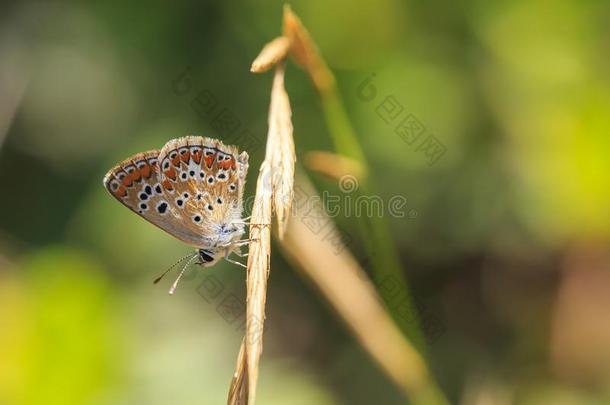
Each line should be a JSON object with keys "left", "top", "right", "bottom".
{"left": 228, "top": 57, "right": 296, "bottom": 405}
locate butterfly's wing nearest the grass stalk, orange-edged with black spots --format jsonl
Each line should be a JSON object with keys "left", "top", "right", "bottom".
{"left": 158, "top": 136, "right": 248, "bottom": 247}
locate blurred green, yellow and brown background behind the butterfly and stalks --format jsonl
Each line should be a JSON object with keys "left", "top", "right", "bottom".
{"left": 0, "top": 0, "right": 610, "bottom": 405}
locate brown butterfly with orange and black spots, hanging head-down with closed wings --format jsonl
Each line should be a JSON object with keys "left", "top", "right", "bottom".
{"left": 104, "top": 136, "right": 249, "bottom": 294}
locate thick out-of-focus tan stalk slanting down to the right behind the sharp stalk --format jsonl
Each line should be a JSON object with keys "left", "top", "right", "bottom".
{"left": 281, "top": 175, "right": 442, "bottom": 403}
